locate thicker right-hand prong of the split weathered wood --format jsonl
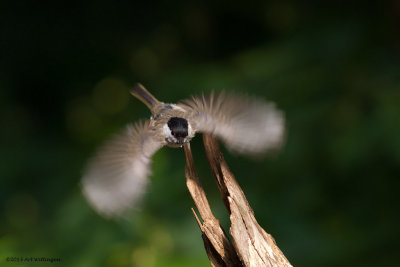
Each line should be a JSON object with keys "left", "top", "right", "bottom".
{"left": 203, "top": 134, "right": 291, "bottom": 267}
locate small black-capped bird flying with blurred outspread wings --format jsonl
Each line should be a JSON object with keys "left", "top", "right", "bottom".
{"left": 81, "top": 83, "right": 285, "bottom": 218}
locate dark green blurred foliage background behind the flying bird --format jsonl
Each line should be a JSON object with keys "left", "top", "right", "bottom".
{"left": 0, "top": 0, "right": 400, "bottom": 267}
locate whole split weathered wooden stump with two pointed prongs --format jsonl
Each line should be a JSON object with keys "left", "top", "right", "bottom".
{"left": 185, "top": 134, "right": 291, "bottom": 267}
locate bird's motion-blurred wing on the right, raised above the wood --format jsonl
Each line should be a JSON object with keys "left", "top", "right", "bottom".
{"left": 180, "top": 92, "right": 285, "bottom": 154}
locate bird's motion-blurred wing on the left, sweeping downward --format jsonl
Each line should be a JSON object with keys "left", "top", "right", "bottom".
{"left": 82, "top": 121, "right": 161, "bottom": 217}
